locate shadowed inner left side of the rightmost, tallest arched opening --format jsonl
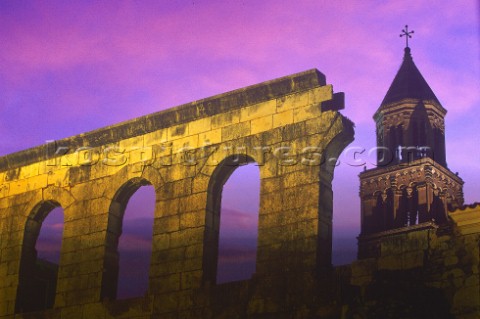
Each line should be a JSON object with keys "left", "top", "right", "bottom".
{"left": 203, "top": 154, "right": 261, "bottom": 283}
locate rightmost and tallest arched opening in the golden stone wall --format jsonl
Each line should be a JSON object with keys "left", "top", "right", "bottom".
{"left": 204, "top": 156, "right": 260, "bottom": 284}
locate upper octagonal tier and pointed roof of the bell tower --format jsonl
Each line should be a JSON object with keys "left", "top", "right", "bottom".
{"left": 373, "top": 47, "right": 447, "bottom": 167}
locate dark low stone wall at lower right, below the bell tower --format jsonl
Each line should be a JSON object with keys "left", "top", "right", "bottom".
{"left": 344, "top": 205, "right": 480, "bottom": 319}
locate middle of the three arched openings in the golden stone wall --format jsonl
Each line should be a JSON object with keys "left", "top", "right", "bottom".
{"left": 101, "top": 178, "right": 155, "bottom": 300}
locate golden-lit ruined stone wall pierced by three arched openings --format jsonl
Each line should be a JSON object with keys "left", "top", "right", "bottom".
{"left": 0, "top": 70, "right": 353, "bottom": 319}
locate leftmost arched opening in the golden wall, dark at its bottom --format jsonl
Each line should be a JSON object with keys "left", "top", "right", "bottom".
{"left": 16, "top": 201, "right": 64, "bottom": 313}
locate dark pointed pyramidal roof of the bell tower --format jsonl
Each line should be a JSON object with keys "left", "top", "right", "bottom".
{"left": 381, "top": 47, "right": 441, "bottom": 106}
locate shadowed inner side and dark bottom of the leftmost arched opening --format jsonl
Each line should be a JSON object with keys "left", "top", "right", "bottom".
{"left": 15, "top": 199, "right": 65, "bottom": 313}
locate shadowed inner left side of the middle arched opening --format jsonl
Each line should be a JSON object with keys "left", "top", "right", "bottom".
{"left": 100, "top": 177, "right": 153, "bottom": 300}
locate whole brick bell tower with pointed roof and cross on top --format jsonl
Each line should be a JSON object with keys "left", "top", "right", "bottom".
{"left": 359, "top": 29, "right": 463, "bottom": 258}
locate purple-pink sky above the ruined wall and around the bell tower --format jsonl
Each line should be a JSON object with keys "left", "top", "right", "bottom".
{"left": 0, "top": 0, "right": 480, "bottom": 268}
